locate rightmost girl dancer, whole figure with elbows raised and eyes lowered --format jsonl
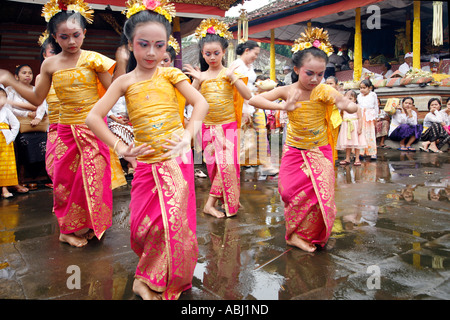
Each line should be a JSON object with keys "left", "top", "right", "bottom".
{"left": 250, "top": 28, "right": 358, "bottom": 252}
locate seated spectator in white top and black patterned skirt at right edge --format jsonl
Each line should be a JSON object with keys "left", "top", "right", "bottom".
{"left": 420, "top": 98, "right": 450, "bottom": 153}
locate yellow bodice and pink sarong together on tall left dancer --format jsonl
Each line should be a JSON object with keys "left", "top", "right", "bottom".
{"left": 52, "top": 50, "right": 115, "bottom": 239}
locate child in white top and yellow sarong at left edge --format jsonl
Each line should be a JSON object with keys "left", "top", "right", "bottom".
{"left": 0, "top": 88, "right": 20, "bottom": 199}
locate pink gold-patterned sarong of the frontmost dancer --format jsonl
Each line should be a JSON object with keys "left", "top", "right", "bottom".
{"left": 130, "top": 152, "right": 198, "bottom": 300}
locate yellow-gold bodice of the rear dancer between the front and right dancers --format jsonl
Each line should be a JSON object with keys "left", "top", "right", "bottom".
{"left": 200, "top": 68, "right": 242, "bottom": 125}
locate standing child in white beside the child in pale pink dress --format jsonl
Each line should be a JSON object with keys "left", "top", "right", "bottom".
{"left": 357, "top": 79, "right": 378, "bottom": 160}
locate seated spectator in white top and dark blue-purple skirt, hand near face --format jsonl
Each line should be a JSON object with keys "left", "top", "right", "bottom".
{"left": 389, "top": 97, "right": 422, "bottom": 151}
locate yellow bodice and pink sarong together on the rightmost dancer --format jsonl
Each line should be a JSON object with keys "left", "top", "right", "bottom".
{"left": 278, "top": 84, "right": 342, "bottom": 246}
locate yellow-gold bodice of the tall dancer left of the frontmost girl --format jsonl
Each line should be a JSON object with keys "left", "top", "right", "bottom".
{"left": 53, "top": 50, "right": 115, "bottom": 124}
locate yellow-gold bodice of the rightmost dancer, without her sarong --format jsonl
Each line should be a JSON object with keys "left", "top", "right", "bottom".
{"left": 286, "top": 84, "right": 342, "bottom": 149}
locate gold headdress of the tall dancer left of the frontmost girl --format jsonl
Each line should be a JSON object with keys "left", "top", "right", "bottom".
{"left": 41, "top": 0, "right": 94, "bottom": 23}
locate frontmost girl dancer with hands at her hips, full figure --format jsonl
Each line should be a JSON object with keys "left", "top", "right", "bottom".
{"left": 86, "top": 0, "right": 208, "bottom": 300}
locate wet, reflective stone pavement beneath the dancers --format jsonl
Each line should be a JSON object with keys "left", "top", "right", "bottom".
{"left": 0, "top": 149, "right": 450, "bottom": 301}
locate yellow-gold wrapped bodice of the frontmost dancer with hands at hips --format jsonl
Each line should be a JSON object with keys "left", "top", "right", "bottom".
{"left": 125, "top": 67, "right": 188, "bottom": 163}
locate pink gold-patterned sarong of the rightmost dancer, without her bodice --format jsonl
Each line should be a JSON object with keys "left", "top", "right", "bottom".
{"left": 279, "top": 145, "right": 336, "bottom": 247}
